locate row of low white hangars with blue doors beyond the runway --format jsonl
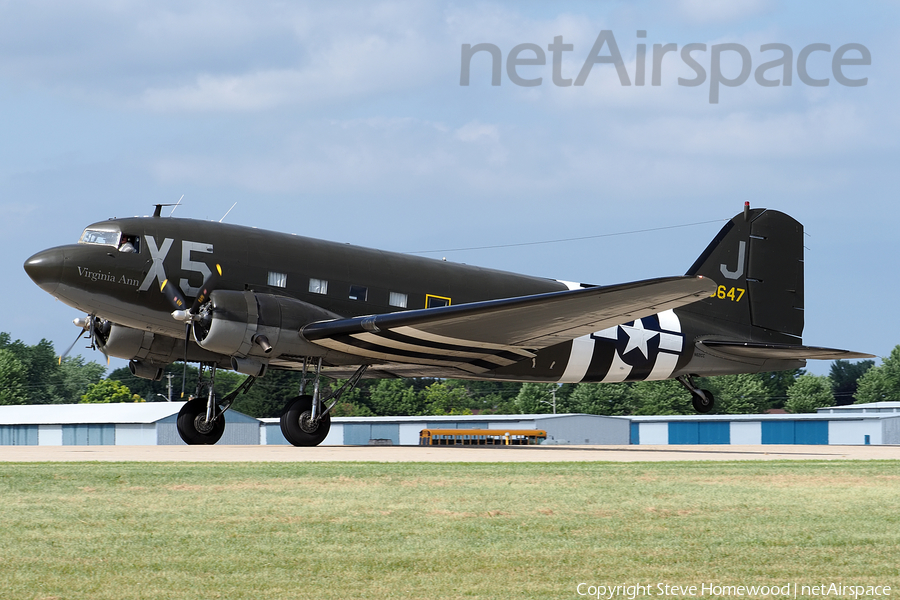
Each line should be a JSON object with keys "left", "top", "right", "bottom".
{"left": 0, "top": 402, "right": 900, "bottom": 446}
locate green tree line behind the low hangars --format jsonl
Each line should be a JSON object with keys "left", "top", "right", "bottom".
{"left": 0, "top": 333, "right": 900, "bottom": 417}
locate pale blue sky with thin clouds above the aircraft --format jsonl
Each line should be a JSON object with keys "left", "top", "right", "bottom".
{"left": 0, "top": 0, "right": 900, "bottom": 374}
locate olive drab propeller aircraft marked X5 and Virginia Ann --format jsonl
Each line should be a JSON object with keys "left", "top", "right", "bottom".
{"left": 25, "top": 205, "right": 870, "bottom": 446}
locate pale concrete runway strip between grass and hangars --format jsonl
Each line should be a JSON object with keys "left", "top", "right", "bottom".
{"left": 0, "top": 445, "right": 900, "bottom": 463}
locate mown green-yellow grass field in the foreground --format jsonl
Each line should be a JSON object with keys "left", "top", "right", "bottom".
{"left": 0, "top": 461, "right": 900, "bottom": 600}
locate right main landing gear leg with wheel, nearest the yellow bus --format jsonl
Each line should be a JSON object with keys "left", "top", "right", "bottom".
{"left": 281, "top": 358, "right": 368, "bottom": 446}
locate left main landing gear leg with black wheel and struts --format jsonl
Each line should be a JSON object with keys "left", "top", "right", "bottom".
{"left": 176, "top": 363, "right": 256, "bottom": 445}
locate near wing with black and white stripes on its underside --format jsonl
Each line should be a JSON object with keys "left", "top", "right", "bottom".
{"left": 300, "top": 276, "right": 716, "bottom": 373}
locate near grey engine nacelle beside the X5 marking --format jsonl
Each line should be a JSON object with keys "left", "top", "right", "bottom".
{"left": 193, "top": 290, "right": 339, "bottom": 361}
